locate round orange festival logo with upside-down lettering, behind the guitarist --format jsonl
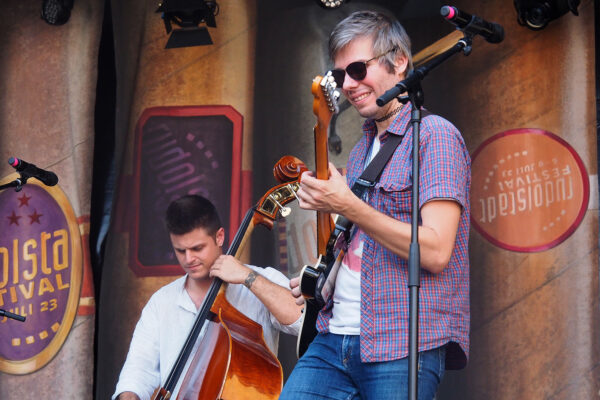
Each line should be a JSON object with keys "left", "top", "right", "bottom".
{"left": 471, "top": 129, "right": 590, "bottom": 252}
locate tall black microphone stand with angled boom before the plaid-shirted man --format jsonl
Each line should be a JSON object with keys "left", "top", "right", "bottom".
{"left": 377, "top": 32, "right": 473, "bottom": 400}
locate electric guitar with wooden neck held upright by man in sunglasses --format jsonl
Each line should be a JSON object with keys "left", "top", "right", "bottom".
{"left": 296, "top": 72, "right": 349, "bottom": 357}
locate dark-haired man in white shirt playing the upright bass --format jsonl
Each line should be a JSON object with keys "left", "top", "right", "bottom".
{"left": 113, "top": 195, "right": 300, "bottom": 400}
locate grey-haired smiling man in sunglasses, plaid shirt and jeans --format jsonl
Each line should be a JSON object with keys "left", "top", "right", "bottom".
{"left": 280, "top": 11, "right": 471, "bottom": 400}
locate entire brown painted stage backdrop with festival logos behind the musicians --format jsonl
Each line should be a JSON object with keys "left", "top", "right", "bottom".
{"left": 0, "top": 0, "right": 600, "bottom": 400}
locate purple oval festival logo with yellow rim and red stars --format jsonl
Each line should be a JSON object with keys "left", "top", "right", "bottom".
{"left": 0, "top": 174, "right": 82, "bottom": 374}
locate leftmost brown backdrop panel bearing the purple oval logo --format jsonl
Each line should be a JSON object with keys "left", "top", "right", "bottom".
{"left": 0, "top": 0, "right": 103, "bottom": 400}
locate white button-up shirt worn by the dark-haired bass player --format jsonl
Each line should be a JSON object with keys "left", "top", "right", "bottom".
{"left": 112, "top": 265, "right": 302, "bottom": 400}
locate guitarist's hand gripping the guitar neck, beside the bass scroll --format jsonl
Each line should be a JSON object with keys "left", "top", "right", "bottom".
{"left": 297, "top": 163, "right": 360, "bottom": 215}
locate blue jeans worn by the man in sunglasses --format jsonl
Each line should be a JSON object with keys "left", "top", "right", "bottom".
{"left": 279, "top": 333, "right": 446, "bottom": 400}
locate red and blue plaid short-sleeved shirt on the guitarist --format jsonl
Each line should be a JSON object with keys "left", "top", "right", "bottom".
{"left": 317, "top": 106, "right": 471, "bottom": 369}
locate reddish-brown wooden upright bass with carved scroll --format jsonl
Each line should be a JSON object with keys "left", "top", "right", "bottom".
{"left": 152, "top": 156, "right": 306, "bottom": 400}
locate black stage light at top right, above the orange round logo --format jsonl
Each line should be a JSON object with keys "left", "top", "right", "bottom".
{"left": 514, "top": 0, "right": 580, "bottom": 31}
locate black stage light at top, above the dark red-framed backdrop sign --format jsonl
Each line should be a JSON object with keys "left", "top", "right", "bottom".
{"left": 156, "top": 0, "right": 219, "bottom": 49}
